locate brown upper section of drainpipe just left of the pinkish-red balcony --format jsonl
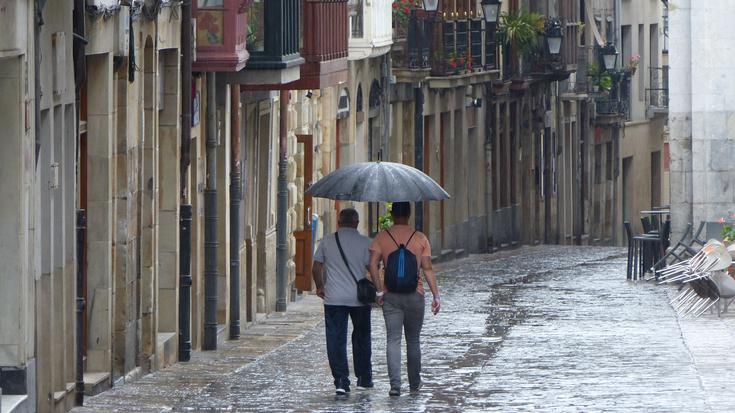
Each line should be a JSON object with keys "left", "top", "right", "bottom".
{"left": 181, "top": 0, "right": 192, "bottom": 197}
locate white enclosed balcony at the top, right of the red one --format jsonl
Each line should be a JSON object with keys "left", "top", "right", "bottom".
{"left": 347, "top": 0, "right": 393, "bottom": 60}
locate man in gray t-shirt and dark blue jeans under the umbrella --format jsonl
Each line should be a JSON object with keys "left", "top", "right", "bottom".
{"left": 311, "top": 208, "right": 373, "bottom": 395}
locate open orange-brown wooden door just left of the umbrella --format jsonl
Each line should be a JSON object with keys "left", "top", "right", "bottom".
{"left": 294, "top": 135, "right": 314, "bottom": 291}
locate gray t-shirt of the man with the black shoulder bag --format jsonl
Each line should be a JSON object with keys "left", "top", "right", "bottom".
{"left": 314, "top": 228, "right": 371, "bottom": 307}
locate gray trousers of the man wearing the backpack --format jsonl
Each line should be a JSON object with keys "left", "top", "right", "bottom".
{"left": 383, "top": 292, "right": 424, "bottom": 389}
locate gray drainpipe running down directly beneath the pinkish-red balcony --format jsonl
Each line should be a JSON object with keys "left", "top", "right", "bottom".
{"left": 202, "top": 72, "right": 219, "bottom": 350}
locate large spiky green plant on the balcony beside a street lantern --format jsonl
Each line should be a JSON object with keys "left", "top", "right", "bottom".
{"left": 496, "top": 10, "right": 544, "bottom": 76}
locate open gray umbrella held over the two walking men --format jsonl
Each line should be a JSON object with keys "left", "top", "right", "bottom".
{"left": 306, "top": 162, "right": 449, "bottom": 202}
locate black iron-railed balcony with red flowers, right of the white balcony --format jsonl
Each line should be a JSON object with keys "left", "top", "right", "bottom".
{"left": 391, "top": 10, "right": 498, "bottom": 87}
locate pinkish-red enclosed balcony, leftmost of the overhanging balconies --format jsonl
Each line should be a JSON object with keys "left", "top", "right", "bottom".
{"left": 192, "top": 0, "right": 248, "bottom": 72}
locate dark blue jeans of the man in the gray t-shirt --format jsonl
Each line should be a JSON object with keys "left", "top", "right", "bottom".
{"left": 324, "top": 305, "right": 373, "bottom": 388}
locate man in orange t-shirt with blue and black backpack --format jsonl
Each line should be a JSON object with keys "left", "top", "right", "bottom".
{"left": 370, "top": 202, "right": 441, "bottom": 396}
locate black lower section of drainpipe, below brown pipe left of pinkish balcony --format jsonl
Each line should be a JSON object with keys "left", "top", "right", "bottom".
{"left": 179, "top": 204, "right": 192, "bottom": 361}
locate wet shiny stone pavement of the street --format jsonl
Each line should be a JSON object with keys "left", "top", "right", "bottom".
{"left": 75, "top": 246, "right": 735, "bottom": 412}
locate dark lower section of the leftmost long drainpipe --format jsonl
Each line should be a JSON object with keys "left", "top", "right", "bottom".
{"left": 74, "top": 209, "right": 87, "bottom": 406}
